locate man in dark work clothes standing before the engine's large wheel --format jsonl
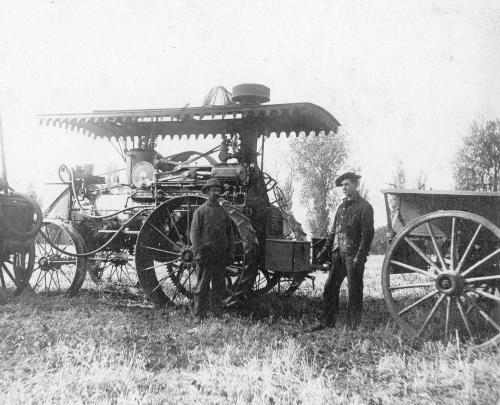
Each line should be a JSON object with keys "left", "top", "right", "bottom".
{"left": 190, "top": 179, "right": 234, "bottom": 321}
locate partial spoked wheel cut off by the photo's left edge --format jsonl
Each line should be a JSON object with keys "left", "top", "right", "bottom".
{"left": 0, "top": 243, "right": 35, "bottom": 296}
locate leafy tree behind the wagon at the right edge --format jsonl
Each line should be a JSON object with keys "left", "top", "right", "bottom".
{"left": 454, "top": 119, "right": 500, "bottom": 191}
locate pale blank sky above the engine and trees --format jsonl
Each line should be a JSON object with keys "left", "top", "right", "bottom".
{"left": 0, "top": 0, "right": 500, "bottom": 225}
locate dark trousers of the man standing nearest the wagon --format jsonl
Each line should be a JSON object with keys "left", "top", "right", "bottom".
{"left": 323, "top": 251, "right": 365, "bottom": 328}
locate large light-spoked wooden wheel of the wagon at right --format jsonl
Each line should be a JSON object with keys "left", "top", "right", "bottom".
{"left": 382, "top": 211, "right": 500, "bottom": 347}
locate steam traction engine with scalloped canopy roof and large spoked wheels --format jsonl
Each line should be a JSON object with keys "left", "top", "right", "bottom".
{"left": 38, "top": 84, "right": 340, "bottom": 305}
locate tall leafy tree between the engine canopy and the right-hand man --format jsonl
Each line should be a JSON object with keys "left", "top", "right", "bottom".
{"left": 290, "top": 134, "right": 349, "bottom": 237}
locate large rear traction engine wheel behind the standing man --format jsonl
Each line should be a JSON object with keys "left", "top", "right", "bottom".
{"left": 135, "top": 195, "right": 256, "bottom": 306}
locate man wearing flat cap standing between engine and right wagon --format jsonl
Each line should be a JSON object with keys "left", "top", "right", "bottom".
{"left": 313, "top": 172, "right": 374, "bottom": 330}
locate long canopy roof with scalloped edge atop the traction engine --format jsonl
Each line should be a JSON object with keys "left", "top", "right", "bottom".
{"left": 37, "top": 103, "right": 340, "bottom": 140}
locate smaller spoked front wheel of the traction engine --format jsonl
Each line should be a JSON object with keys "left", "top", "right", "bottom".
{"left": 31, "top": 221, "right": 87, "bottom": 297}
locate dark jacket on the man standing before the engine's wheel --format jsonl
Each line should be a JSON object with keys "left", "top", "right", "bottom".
{"left": 190, "top": 201, "right": 234, "bottom": 261}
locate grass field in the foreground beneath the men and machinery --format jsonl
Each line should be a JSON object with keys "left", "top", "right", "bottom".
{"left": 0, "top": 256, "right": 500, "bottom": 404}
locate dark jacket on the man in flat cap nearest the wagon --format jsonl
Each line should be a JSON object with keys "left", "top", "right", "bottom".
{"left": 325, "top": 193, "right": 374, "bottom": 263}
